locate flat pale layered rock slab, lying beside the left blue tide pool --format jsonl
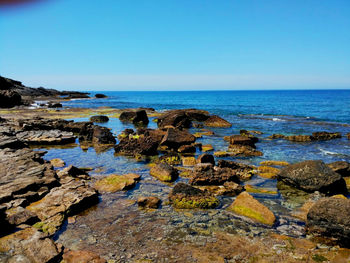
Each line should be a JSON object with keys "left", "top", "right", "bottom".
{"left": 16, "top": 130, "right": 76, "bottom": 145}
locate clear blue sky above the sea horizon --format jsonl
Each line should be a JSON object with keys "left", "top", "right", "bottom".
{"left": 0, "top": 0, "right": 350, "bottom": 90}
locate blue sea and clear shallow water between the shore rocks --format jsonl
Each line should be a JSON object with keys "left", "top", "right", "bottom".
{"left": 38, "top": 91, "right": 350, "bottom": 261}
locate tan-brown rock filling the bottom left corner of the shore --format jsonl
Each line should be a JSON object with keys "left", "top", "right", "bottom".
{"left": 0, "top": 227, "right": 62, "bottom": 263}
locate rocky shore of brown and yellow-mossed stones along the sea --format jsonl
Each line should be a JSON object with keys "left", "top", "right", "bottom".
{"left": 0, "top": 77, "right": 350, "bottom": 263}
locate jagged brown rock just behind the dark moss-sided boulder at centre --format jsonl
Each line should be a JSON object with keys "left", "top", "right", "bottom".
{"left": 189, "top": 163, "right": 239, "bottom": 185}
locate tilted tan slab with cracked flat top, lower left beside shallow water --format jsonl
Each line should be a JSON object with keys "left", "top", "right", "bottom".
{"left": 26, "top": 178, "right": 98, "bottom": 235}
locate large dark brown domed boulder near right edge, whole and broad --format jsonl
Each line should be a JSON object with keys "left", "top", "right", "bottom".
{"left": 278, "top": 161, "right": 346, "bottom": 194}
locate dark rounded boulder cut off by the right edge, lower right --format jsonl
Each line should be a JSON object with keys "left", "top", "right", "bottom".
{"left": 306, "top": 197, "right": 350, "bottom": 247}
